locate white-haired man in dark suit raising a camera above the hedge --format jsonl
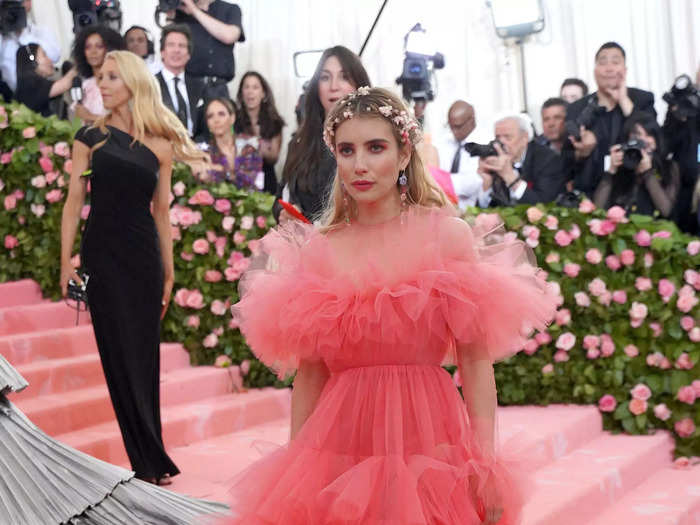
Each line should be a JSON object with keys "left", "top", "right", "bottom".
{"left": 478, "top": 115, "right": 565, "bottom": 208}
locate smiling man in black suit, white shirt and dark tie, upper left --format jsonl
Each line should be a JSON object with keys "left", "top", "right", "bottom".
{"left": 156, "top": 24, "right": 205, "bottom": 140}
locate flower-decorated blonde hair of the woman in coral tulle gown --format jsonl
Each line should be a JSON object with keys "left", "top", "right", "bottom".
{"left": 321, "top": 87, "right": 451, "bottom": 232}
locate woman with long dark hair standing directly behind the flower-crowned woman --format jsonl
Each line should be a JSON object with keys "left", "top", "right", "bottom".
{"left": 277, "top": 46, "right": 370, "bottom": 221}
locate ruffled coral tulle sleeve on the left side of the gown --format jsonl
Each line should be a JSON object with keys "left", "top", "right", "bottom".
{"left": 232, "top": 221, "right": 325, "bottom": 377}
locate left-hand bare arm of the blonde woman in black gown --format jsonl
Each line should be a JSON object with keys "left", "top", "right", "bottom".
{"left": 61, "top": 140, "right": 90, "bottom": 297}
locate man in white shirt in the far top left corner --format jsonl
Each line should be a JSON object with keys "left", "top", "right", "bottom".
{"left": 0, "top": 0, "right": 61, "bottom": 91}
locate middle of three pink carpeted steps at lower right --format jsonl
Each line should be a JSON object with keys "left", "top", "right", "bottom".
{"left": 523, "top": 432, "right": 673, "bottom": 525}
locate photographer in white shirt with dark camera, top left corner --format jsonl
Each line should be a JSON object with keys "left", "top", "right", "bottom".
{"left": 0, "top": 0, "right": 61, "bottom": 91}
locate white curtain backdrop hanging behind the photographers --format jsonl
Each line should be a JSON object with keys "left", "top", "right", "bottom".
{"left": 33, "top": 0, "right": 700, "bottom": 164}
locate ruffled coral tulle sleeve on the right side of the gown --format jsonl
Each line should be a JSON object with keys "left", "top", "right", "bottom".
{"left": 440, "top": 211, "right": 557, "bottom": 363}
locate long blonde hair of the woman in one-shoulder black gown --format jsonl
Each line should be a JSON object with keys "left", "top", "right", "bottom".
{"left": 92, "top": 51, "right": 206, "bottom": 161}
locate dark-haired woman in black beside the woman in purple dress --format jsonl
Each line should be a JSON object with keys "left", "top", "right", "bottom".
{"left": 234, "top": 71, "right": 285, "bottom": 194}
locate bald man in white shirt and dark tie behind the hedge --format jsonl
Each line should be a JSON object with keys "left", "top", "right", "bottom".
{"left": 437, "top": 100, "right": 481, "bottom": 210}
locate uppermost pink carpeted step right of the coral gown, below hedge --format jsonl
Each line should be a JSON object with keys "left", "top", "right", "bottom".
{"left": 497, "top": 405, "right": 603, "bottom": 469}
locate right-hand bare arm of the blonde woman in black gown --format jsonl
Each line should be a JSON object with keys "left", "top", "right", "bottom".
{"left": 152, "top": 140, "right": 175, "bottom": 319}
